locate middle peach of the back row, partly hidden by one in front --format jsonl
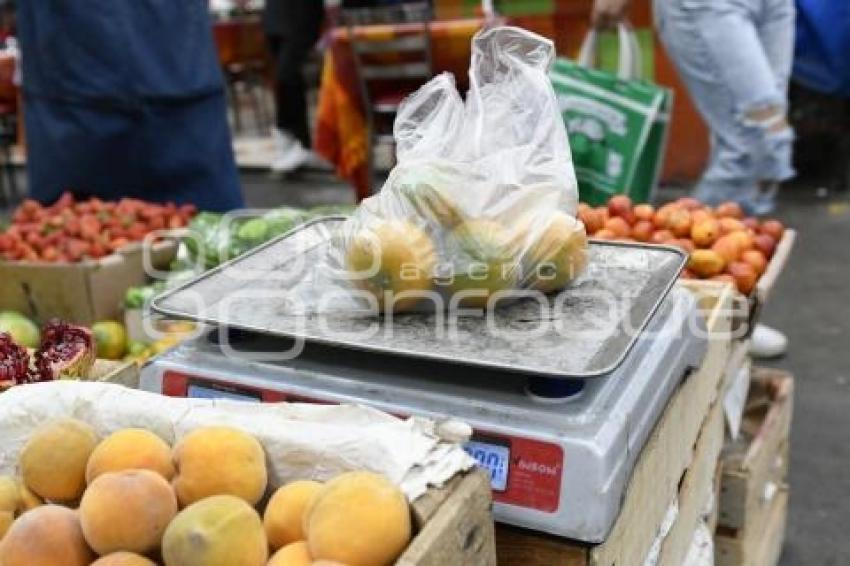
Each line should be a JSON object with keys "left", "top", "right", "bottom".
{"left": 86, "top": 428, "right": 174, "bottom": 483}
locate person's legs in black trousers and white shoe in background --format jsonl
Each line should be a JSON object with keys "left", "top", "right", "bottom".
{"left": 263, "top": 0, "right": 325, "bottom": 172}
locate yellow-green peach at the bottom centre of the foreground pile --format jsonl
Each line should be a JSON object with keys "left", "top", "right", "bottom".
{"left": 162, "top": 495, "right": 268, "bottom": 566}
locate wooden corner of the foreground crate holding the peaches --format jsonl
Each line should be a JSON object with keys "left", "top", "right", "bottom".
{"left": 396, "top": 469, "right": 496, "bottom": 566}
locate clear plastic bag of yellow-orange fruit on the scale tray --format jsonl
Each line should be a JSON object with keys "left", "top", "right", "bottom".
{"left": 296, "top": 27, "right": 587, "bottom": 312}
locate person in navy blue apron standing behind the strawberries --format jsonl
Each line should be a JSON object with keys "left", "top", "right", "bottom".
{"left": 17, "top": 0, "right": 243, "bottom": 211}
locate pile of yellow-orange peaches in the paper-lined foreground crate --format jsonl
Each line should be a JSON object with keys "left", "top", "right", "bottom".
{"left": 0, "top": 419, "right": 411, "bottom": 566}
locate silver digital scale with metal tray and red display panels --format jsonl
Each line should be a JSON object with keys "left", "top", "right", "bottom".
{"left": 141, "top": 219, "right": 706, "bottom": 542}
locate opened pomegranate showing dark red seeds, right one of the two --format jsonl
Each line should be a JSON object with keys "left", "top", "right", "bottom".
{"left": 33, "top": 320, "right": 97, "bottom": 381}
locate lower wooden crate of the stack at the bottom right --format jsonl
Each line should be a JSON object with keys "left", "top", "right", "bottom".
{"left": 714, "top": 485, "right": 788, "bottom": 566}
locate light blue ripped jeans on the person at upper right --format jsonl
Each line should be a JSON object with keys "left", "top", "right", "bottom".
{"left": 655, "top": 0, "right": 795, "bottom": 214}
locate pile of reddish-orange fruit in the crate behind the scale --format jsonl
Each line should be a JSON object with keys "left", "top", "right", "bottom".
{"left": 578, "top": 195, "right": 785, "bottom": 295}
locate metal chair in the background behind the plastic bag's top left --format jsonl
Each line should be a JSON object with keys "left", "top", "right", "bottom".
{"left": 342, "top": 2, "right": 433, "bottom": 195}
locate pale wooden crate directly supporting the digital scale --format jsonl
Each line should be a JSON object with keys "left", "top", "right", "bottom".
{"left": 496, "top": 284, "right": 733, "bottom": 566}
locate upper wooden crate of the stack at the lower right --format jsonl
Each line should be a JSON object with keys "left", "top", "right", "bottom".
{"left": 718, "top": 369, "right": 794, "bottom": 536}
